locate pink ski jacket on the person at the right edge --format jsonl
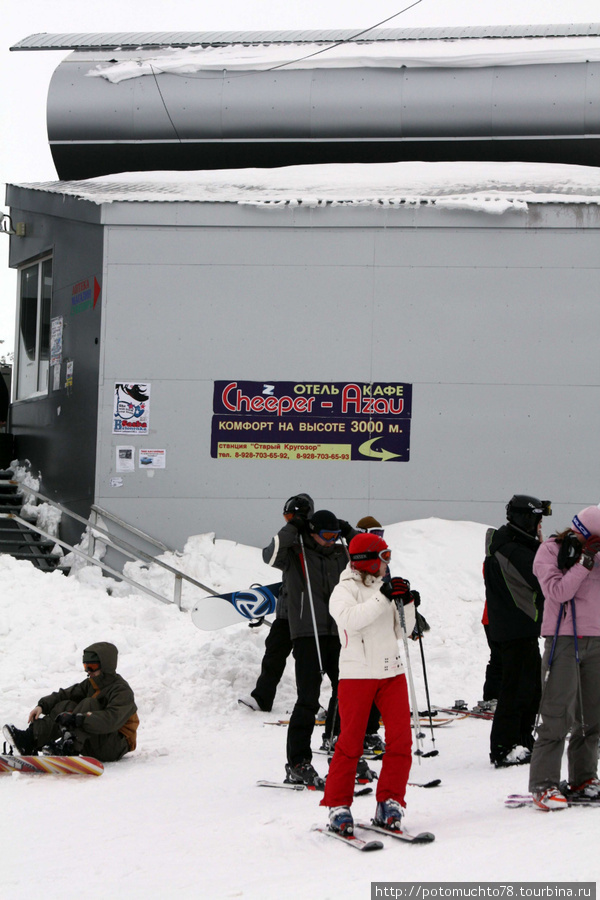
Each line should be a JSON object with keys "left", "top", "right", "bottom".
{"left": 533, "top": 538, "right": 600, "bottom": 637}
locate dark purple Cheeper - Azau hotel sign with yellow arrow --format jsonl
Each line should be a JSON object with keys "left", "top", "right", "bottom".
{"left": 211, "top": 381, "right": 412, "bottom": 462}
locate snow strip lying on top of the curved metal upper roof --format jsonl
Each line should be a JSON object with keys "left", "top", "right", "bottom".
{"left": 84, "top": 36, "right": 600, "bottom": 84}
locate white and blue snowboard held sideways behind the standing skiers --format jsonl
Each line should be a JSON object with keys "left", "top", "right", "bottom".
{"left": 191, "top": 581, "right": 281, "bottom": 631}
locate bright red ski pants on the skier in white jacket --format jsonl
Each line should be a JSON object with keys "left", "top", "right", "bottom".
{"left": 321, "top": 675, "right": 412, "bottom": 806}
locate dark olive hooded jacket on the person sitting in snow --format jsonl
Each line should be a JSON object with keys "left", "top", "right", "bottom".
{"left": 38, "top": 642, "right": 138, "bottom": 750}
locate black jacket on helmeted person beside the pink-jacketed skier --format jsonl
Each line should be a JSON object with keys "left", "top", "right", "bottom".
{"left": 483, "top": 523, "right": 544, "bottom": 641}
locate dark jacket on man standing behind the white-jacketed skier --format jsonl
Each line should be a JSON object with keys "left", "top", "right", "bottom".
{"left": 263, "top": 522, "right": 358, "bottom": 640}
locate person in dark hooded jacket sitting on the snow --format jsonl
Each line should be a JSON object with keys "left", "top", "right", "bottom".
{"left": 3, "top": 641, "right": 139, "bottom": 762}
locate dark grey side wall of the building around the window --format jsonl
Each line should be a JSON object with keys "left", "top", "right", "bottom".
{"left": 7, "top": 187, "right": 103, "bottom": 540}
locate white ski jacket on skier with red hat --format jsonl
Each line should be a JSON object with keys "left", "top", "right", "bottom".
{"left": 329, "top": 564, "right": 415, "bottom": 679}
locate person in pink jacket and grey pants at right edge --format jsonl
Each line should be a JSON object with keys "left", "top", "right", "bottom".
{"left": 529, "top": 506, "right": 600, "bottom": 810}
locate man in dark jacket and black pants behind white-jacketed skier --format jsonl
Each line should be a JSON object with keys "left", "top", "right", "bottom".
{"left": 263, "top": 509, "right": 356, "bottom": 790}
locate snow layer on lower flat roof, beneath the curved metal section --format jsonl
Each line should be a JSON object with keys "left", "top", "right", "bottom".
{"left": 11, "top": 162, "right": 600, "bottom": 214}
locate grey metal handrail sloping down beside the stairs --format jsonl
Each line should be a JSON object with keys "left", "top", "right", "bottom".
{"left": 0, "top": 481, "right": 217, "bottom": 609}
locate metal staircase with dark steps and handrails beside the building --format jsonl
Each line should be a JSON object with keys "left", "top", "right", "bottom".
{"left": 0, "top": 470, "right": 216, "bottom": 609}
